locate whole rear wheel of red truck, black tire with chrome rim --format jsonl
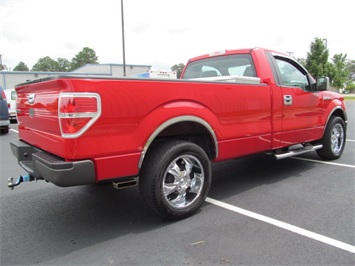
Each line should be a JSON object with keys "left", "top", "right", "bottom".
{"left": 139, "top": 141, "right": 212, "bottom": 220}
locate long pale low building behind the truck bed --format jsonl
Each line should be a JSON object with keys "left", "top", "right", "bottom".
{"left": 0, "top": 64, "right": 152, "bottom": 90}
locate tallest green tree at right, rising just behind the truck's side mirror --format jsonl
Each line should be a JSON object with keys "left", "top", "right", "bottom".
{"left": 306, "top": 38, "right": 332, "bottom": 78}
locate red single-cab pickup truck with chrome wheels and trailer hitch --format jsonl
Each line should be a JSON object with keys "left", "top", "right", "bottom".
{"left": 8, "top": 48, "right": 347, "bottom": 219}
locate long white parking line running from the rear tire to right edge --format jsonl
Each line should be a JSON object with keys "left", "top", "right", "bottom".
{"left": 206, "top": 198, "right": 355, "bottom": 253}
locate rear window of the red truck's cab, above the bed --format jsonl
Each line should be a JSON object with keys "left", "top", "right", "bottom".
{"left": 183, "top": 54, "right": 257, "bottom": 79}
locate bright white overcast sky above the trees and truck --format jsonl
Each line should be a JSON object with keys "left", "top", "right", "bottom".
{"left": 0, "top": 0, "right": 355, "bottom": 70}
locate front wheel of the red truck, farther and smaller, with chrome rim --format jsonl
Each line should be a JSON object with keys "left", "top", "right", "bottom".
{"left": 317, "top": 116, "right": 346, "bottom": 160}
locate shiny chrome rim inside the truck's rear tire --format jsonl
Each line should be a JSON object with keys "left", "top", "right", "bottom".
{"left": 162, "top": 155, "right": 204, "bottom": 208}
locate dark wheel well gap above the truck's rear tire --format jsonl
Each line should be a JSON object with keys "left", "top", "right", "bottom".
{"left": 151, "top": 121, "right": 216, "bottom": 160}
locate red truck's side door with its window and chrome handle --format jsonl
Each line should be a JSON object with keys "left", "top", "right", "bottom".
{"left": 274, "top": 56, "right": 323, "bottom": 146}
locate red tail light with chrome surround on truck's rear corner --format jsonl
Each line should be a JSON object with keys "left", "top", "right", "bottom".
{"left": 58, "top": 93, "right": 101, "bottom": 138}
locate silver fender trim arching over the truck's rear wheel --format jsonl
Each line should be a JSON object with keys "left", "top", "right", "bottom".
{"left": 138, "top": 115, "right": 218, "bottom": 169}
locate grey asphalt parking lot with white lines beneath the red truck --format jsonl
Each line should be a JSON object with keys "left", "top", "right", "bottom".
{"left": 0, "top": 101, "right": 355, "bottom": 265}
